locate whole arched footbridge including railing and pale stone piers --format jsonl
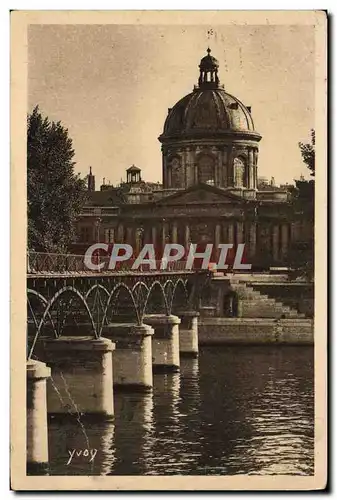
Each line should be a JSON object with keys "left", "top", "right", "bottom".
{"left": 27, "top": 252, "right": 210, "bottom": 470}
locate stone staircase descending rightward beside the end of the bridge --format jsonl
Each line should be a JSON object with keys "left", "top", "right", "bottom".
{"left": 231, "top": 278, "right": 305, "bottom": 319}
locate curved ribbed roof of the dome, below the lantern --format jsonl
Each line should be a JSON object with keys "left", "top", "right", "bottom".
{"left": 162, "top": 88, "right": 259, "bottom": 137}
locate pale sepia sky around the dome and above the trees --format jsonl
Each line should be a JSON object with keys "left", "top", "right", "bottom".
{"left": 27, "top": 24, "right": 315, "bottom": 189}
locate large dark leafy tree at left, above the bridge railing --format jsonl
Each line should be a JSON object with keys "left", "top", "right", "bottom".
{"left": 27, "top": 106, "right": 86, "bottom": 252}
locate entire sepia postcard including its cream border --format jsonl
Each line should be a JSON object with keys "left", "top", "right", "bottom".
{"left": 11, "top": 11, "right": 327, "bottom": 490}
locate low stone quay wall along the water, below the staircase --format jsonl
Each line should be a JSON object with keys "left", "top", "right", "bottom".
{"left": 198, "top": 317, "right": 314, "bottom": 345}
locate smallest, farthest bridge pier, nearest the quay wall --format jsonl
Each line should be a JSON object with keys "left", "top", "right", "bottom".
{"left": 178, "top": 311, "right": 199, "bottom": 358}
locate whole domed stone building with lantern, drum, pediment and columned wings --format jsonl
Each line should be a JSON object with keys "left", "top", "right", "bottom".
{"left": 78, "top": 49, "right": 311, "bottom": 270}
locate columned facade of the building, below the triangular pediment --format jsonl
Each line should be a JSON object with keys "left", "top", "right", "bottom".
{"left": 109, "top": 207, "right": 294, "bottom": 269}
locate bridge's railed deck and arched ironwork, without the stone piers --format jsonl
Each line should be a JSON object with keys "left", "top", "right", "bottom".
{"left": 27, "top": 252, "right": 209, "bottom": 359}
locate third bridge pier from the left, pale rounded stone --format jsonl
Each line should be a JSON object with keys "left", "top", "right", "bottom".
{"left": 103, "top": 323, "right": 154, "bottom": 392}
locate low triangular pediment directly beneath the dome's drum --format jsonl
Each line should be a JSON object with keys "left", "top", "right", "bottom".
{"left": 156, "top": 185, "right": 244, "bottom": 206}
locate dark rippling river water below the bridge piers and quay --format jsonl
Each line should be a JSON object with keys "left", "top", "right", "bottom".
{"left": 49, "top": 346, "right": 314, "bottom": 475}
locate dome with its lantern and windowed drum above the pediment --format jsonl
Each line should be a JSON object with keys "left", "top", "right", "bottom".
{"left": 159, "top": 49, "right": 261, "bottom": 194}
